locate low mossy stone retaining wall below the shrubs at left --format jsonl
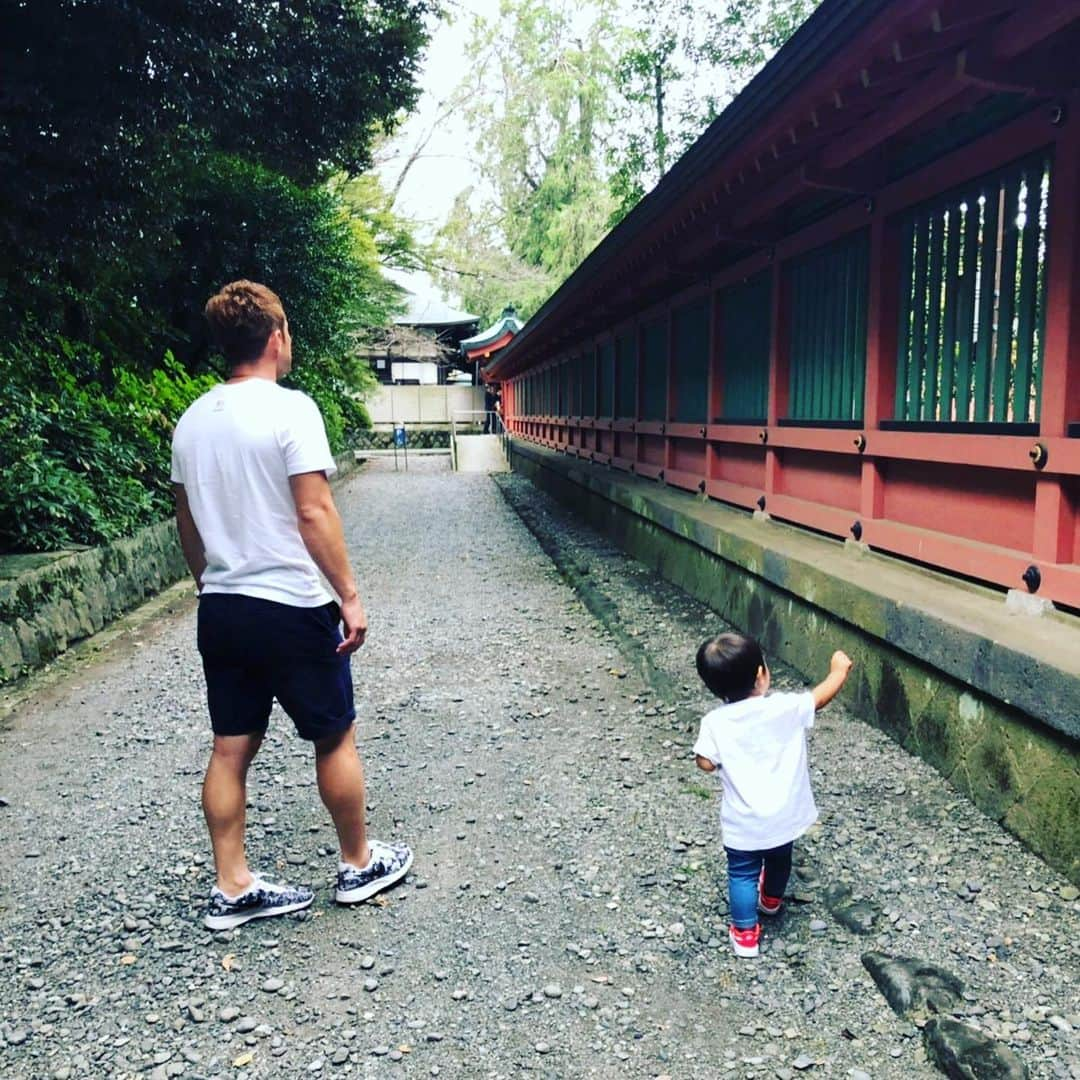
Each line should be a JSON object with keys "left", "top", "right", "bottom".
{"left": 0, "top": 453, "right": 356, "bottom": 684}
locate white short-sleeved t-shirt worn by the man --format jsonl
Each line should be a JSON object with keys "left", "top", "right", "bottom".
{"left": 172, "top": 378, "right": 337, "bottom": 607}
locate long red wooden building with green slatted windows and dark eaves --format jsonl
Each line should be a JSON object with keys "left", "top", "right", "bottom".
{"left": 489, "top": 0, "right": 1080, "bottom": 608}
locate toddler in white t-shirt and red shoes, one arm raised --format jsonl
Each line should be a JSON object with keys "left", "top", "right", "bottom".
{"left": 693, "top": 634, "right": 851, "bottom": 956}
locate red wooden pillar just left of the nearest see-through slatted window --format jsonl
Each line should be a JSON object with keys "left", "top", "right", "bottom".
{"left": 859, "top": 213, "right": 902, "bottom": 521}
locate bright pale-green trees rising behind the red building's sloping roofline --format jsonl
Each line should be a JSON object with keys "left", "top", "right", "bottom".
{"left": 435, "top": 0, "right": 819, "bottom": 308}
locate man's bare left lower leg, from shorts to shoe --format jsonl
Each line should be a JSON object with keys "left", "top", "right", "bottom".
{"left": 203, "top": 731, "right": 262, "bottom": 896}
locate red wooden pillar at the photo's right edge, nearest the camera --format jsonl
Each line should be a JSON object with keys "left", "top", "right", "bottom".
{"left": 1032, "top": 100, "right": 1080, "bottom": 563}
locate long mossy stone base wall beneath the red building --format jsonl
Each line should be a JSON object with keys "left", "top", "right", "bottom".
{"left": 512, "top": 441, "right": 1080, "bottom": 882}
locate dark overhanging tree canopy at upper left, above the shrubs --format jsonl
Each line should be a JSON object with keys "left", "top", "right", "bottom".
{"left": 0, "top": 0, "right": 432, "bottom": 334}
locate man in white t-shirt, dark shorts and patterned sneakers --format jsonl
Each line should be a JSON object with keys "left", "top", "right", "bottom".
{"left": 172, "top": 281, "right": 413, "bottom": 930}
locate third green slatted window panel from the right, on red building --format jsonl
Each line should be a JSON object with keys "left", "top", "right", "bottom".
{"left": 719, "top": 270, "right": 772, "bottom": 421}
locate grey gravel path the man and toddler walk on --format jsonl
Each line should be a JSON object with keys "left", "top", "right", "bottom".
{"left": 0, "top": 459, "right": 1080, "bottom": 1080}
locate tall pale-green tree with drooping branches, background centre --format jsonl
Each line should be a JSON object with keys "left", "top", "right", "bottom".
{"left": 436, "top": 0, "right": 622, "bottom": 313}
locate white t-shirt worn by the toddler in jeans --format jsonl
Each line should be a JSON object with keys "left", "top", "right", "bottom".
{"left": 693, "top": 692, "right": 818, "bottom": 851}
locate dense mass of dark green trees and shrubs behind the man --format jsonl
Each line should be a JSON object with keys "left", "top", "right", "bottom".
{"left": 0, "top": 0, "right": 434, "bottom": 551}
